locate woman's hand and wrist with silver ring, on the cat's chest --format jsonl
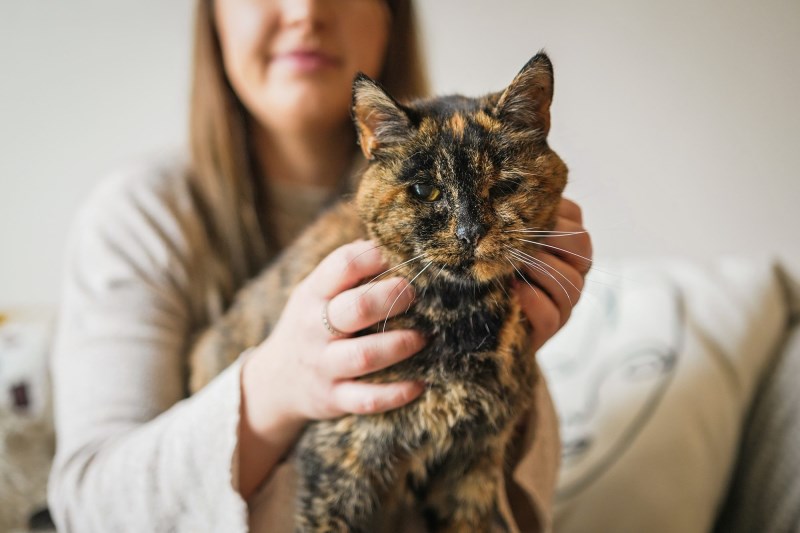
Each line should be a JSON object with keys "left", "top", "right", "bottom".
{"left": 239, "top": 241, "right": 425, "bottom": 498}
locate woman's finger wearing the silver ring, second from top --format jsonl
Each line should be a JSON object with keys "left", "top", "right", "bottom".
{"left": 327, "top": 278, "right": 414, "bottom": 333}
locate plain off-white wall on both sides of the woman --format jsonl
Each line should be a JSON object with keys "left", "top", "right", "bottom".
{"left": 0, "top": 0, "right": 800, "bottom": 307}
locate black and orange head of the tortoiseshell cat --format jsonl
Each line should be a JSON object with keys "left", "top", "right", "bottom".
{"left": 353, "top": 53, "right": 567, "bottom": 284}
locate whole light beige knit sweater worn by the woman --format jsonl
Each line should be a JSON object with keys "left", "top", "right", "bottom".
{"left": 49, "top": 152, "right": 559, "bottom": 533}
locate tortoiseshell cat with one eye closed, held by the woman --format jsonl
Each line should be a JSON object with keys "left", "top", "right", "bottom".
{"left": 190, "top": 53, "right": 567, "bottom": 532}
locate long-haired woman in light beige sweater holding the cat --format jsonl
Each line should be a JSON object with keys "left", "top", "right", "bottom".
{"left": 50, "top": 0, "right": 591, "bottom": 532}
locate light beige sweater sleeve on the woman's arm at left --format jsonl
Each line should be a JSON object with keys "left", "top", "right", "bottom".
{"left": 49, "top": 169, "right": 247, "bottom": 533}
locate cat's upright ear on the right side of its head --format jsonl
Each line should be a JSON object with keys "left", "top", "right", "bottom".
{"left": 495, "top": 52, "right": 553, "bottom": 140}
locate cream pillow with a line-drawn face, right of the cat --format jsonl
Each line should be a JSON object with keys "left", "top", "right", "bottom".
{"left": 539, "top": 260, "right": 787, "bottom": 533}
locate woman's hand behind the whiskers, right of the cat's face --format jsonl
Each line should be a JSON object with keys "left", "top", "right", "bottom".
{"left": 514, "top": 199, "right": 592, "bottom": 350}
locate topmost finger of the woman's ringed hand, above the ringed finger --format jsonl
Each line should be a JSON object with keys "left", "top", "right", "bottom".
{"left": 304, "top": 241, "right": 387, "bottom": 299}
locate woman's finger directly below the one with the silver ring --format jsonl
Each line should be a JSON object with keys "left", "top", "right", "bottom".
{"left": 318, "top": 330, "right": 425, "bottom": 379}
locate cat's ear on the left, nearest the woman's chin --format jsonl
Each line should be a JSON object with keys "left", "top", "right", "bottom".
{"left": 352, "top": 72, "right": 411, "bottom": 159}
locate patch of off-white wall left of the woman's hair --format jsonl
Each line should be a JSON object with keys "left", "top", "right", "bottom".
{"left": 0, "top": 0, "right": 192, "bottom": 308}
